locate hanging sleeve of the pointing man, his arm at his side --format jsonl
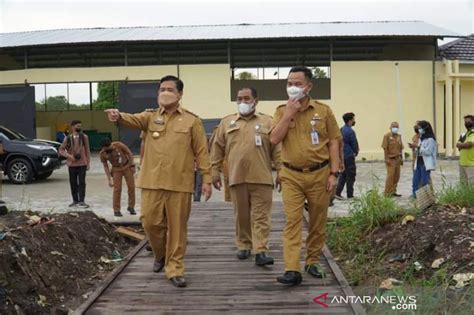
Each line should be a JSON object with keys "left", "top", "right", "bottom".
{"left": 192, "top": 118, "right": 212, "bottom": 184}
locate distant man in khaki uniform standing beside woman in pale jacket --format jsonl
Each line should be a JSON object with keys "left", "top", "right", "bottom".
{"left": 382, "top": 121, "right": 403, "bottom": 197}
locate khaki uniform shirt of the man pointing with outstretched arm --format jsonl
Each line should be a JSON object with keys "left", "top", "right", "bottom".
{"left": 119, "top": 106, "right": 211, "bottom": 193}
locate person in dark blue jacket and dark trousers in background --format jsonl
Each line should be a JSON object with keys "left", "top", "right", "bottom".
{"left": 335, "top": 113, "right": 359, "bottom": 200}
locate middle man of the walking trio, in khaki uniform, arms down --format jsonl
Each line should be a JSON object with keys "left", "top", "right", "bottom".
{"left": 211, "top": 88, "right": 281, "bottom": 266}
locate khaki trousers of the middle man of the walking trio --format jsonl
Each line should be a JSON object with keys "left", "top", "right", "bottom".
{"left": 230, "top": 184, "right": 273, "bottom": 254}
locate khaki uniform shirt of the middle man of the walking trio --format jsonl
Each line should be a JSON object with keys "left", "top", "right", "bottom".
{"left": 211, "top": 113, "right": 281, "bottom": 186}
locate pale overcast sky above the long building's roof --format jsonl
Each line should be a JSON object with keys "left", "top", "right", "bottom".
{"left": 0, "top": 0, "right": 474, "bottom": 35}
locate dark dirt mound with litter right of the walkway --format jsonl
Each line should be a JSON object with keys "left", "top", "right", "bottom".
{"left": 369, "top": 206, "right": 474, "bottom": 279}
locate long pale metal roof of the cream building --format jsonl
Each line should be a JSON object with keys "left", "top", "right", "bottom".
{"left": 0, "top": 21, "right": 460, "bottom": 47}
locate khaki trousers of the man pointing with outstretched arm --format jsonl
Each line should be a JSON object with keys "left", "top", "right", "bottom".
{"left": 140, "top": 189, "right": 192, "bottom": 279}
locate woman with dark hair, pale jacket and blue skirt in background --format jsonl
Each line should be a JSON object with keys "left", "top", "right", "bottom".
{"left": 415, "top": 120, "right": 438, "bottom": 193}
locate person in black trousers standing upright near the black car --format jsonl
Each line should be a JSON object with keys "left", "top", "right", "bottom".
{"left": 59, "top": 120, "right": 91, "bottom": 208}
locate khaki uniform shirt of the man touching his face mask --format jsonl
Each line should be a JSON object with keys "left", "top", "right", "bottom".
{"left": 272, "top": 100, "right": 341, "bottom": 167}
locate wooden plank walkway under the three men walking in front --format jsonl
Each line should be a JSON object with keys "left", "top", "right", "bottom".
{"left": 78, "top": 203, "right": 364, "bottom": 315}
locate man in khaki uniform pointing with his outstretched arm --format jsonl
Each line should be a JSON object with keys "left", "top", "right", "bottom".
{"left": 106, "top": 76, "right": 212, "bottom": 287}
